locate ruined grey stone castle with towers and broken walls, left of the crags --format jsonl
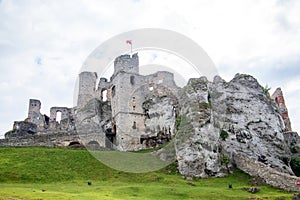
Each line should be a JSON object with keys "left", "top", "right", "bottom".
{"left": 5, "top": 53, "right": 180, "bottom": 151}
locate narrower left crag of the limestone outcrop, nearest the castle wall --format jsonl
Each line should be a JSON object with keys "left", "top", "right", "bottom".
{"left": 175, "top": 77, "right": 227, "bottom": 178}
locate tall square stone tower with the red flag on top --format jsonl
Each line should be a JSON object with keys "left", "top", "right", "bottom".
{"left": 111, "top": 54, "right": 145, "bottom": 150}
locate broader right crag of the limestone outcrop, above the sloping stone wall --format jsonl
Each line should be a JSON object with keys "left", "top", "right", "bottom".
{"left": 219, "top": 74, "right": 293, "bottom": 174}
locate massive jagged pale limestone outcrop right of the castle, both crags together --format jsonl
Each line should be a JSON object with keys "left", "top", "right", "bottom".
{"left": 176, "top": 74, "right": 293, "bottom": 187}
